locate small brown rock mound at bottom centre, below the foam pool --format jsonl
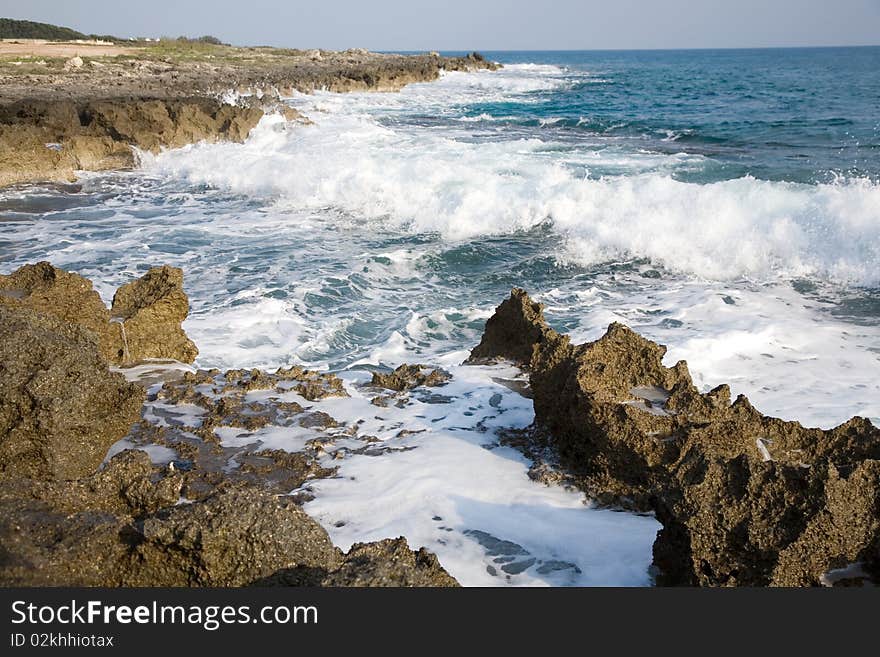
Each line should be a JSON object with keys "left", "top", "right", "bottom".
{"left": 321, "top": 537, "right": 458, "bottom": 587}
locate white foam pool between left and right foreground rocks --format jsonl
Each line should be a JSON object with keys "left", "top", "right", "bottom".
{"left": 305, "top": 367, "right": 659, "bottom": 586}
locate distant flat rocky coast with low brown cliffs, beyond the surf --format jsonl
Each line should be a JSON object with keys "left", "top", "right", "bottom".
{"left": 0, "top": 47, "right": 497, "bottom": 187}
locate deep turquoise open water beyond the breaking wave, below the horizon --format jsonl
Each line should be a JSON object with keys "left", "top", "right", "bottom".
{"left": 471, "top": 47, "right": 880, "bottom": 183}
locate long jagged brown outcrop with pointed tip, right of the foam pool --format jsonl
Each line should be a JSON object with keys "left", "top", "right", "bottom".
{"left": 471, "top": 290, "right": 880, "bottom": 586}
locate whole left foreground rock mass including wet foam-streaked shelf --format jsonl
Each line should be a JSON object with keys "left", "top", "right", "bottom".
{"left": 0, "top": 263, "right": 457, "bottom": 586}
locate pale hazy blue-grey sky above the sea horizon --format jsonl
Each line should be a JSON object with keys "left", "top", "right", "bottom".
{"left": 0, "top": 0, "right": 880, "bottom": 50}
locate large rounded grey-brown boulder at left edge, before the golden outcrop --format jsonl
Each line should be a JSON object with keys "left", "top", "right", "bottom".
{"left": 0, "top": 305, "right": 144, "bottom": 480}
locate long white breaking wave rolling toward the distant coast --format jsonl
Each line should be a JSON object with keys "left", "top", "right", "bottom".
{"left": 146, "top": 113, "right": 880, "bottom": 286}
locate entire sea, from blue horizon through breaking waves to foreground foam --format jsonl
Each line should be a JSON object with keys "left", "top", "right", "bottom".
{"left": 0, "top": 47, "right": 880, "bottom": 586}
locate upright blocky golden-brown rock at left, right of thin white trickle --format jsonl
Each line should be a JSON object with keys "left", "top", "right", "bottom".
{"left": 110, "top": 266, "right": 199, "bottom": 363}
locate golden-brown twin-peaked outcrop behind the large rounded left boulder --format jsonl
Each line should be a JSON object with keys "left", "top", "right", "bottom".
{"left": 0, "top": 262, "right": 198, "bottom": 365}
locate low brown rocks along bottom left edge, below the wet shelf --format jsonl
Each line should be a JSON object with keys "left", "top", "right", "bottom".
{"left": 0, "top": 451, "right": 457, "bottom": 586}
